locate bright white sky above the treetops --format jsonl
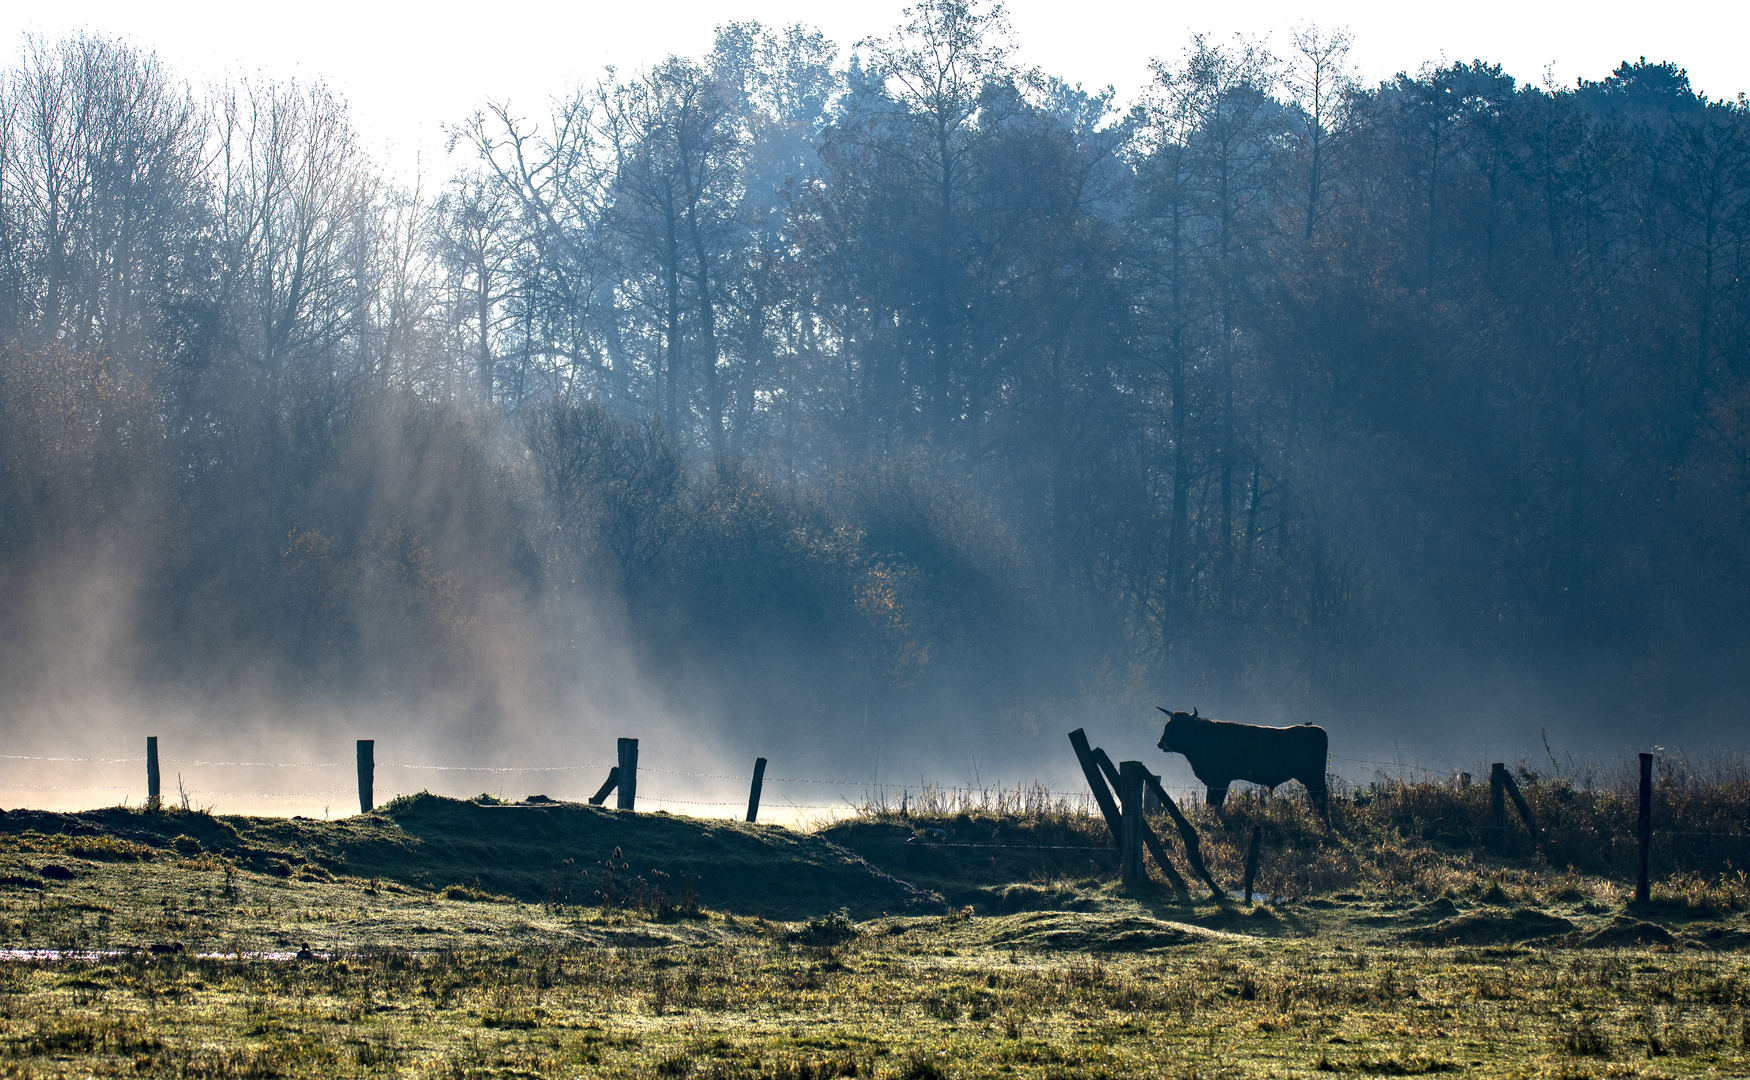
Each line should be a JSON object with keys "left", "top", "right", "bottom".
{"left": 10, "top": 0, "right": 1750, "bottom": 180}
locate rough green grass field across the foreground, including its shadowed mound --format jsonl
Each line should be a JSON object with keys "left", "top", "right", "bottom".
{"left": 0, "top": 770, "right": 1750, "bottom": 1078}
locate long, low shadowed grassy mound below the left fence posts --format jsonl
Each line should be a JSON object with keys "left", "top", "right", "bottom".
{"left": 0, "top": 793, "right": 943, "bottom": 919}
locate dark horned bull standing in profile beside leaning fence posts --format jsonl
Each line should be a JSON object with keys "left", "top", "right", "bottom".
{"left": 1155, "top": 705, "right": 1330, "bottom": 823}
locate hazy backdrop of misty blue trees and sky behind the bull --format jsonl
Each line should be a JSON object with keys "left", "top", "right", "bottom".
{"left": 0, "top": 4, "right": 1750, "bottom": 814}
